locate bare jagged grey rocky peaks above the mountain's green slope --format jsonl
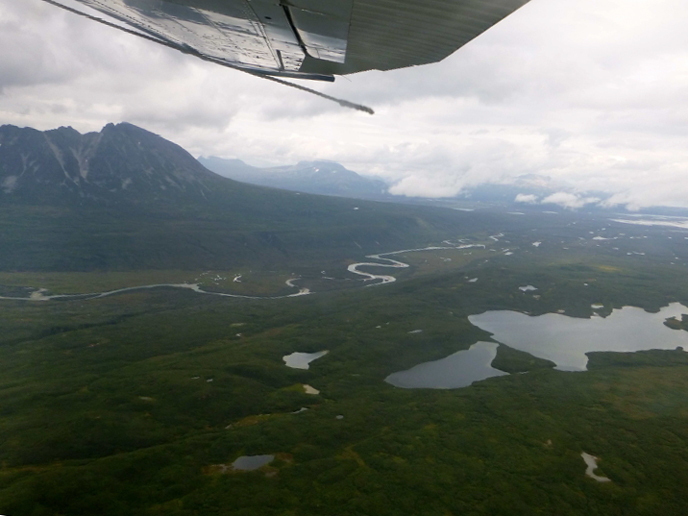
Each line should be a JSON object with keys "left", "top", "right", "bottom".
{"left": 0, "top": 123, "right": 231, "bottom": 203}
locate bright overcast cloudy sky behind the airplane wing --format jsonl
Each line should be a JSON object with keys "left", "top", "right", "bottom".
{"left": 0, "top": 0, "right": 688, "bottom": 208}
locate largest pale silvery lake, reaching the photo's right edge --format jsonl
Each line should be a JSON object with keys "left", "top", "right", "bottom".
{"left": 468, "top": 303, "right": 688, "bottom": 371}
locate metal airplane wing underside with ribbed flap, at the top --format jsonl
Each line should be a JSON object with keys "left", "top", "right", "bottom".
{"left": 70, "top": 0, "right": 529, "bottom": 80}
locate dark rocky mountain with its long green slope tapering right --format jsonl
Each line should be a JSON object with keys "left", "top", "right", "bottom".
{"left": 0, "top": 123, "right": 489, "bottom": 270}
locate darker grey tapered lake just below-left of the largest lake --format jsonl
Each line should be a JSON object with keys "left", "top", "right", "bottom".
{"left": 385, "top": 342, "right": 508, "bottom": 389}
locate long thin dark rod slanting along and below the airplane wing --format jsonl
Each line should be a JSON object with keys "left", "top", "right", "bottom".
{"left": 43, "top": 0, "right": 375, "bottom": 115}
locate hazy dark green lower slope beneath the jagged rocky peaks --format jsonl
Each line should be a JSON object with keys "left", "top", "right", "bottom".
{"left": 0, "top": 195, "right": 516, "bottom": 272}
